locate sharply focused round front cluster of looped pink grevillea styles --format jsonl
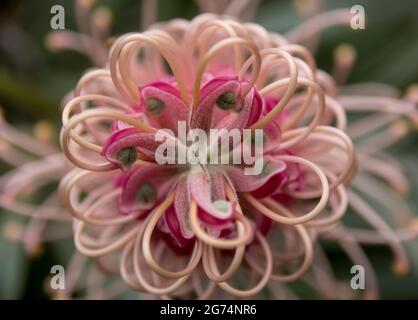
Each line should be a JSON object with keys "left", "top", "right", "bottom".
{"left": 60, "top": 10, "right": 355, "bottom": 297}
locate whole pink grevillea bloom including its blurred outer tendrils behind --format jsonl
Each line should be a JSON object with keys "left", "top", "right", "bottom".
{"left": 1, "top": 1, "right": 418, "bottom": 299}
